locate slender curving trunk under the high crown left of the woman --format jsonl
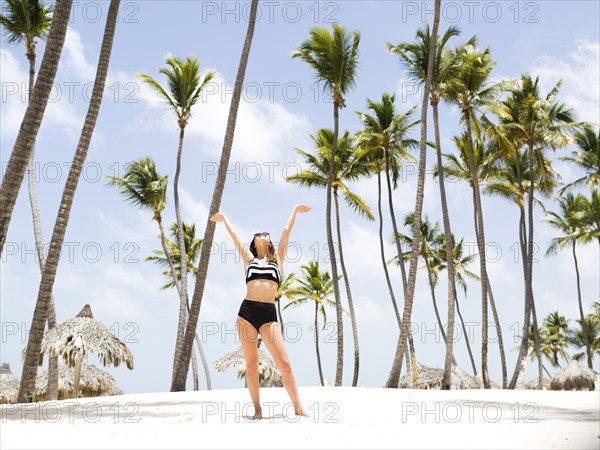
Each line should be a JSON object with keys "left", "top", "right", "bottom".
{"left": 171, "top": 123, "right": 193, "bottom": 382}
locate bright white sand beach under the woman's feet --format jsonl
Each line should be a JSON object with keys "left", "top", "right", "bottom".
{"left": 0, "top": 387, "right": 600, "bottom": 449}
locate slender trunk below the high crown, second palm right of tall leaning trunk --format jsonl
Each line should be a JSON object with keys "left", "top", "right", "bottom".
{"left": 464, "top": 111, "right": 490, "bottom": 389}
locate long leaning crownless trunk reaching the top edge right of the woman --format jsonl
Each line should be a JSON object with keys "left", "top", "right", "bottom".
{"left": 386, "top": 0, "right": 442, "bottom": 388}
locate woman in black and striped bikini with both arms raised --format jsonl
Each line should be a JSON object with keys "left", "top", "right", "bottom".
{"left": 210, "top": 205, "right": 311, "bottom": 419}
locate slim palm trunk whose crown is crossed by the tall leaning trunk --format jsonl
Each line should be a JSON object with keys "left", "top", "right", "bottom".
{"left": 431, "top": 101, "right": 460, "bottom": 390}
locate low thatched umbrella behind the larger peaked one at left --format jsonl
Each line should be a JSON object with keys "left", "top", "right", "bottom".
{"left": 35, "top": 363, "right": 123, "bottom": 401}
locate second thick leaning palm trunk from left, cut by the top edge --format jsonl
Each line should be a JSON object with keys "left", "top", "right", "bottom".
{"left": 17, "top": 0, "right": 120, "bottom": 401}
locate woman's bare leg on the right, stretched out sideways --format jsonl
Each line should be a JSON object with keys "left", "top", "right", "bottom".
{"left": 260, "top": 322, "right": 310, "bottom": 417}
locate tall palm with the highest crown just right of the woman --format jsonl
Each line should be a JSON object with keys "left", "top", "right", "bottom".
{"left": 292, "top": 25, "right": 360, "bottom": 386}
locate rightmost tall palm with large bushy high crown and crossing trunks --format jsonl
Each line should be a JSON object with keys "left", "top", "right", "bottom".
{"left": 488, "top": 74, "right": 584, "bottom": 388}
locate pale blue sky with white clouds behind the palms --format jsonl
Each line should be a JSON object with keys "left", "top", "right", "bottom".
{"left": 0, "top": 0, "right": 600, "bottom": 393}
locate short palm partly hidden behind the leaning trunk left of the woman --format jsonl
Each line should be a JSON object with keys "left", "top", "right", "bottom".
{"left": 146, "top": 222, "right": 211, "bottom": 391}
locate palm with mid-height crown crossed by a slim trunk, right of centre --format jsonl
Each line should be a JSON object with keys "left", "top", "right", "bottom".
{"left": 442, "top": 130, "right": 508, "bottom": 389}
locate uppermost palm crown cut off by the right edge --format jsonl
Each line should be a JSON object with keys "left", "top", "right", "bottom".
{"left": 558, "top": 126, "right": 600, "bottom": 195}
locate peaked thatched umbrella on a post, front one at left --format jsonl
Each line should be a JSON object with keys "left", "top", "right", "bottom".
{"left": 40, "top": 305, "right": 133, "bottom": 397}
